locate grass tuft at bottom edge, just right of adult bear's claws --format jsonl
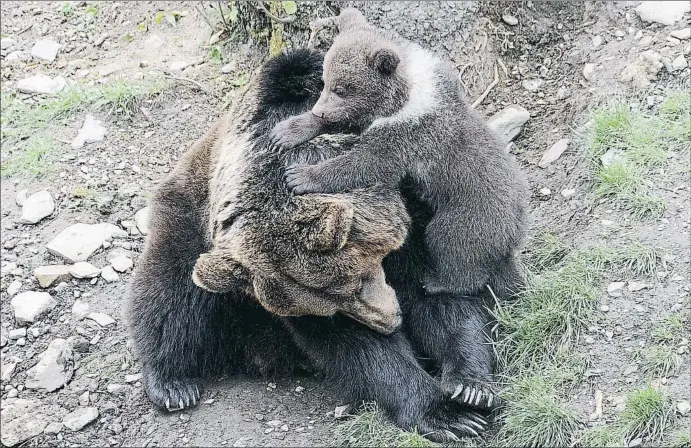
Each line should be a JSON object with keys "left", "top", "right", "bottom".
{"left": 496, "top": 375, "right": 580, "bottom": 447}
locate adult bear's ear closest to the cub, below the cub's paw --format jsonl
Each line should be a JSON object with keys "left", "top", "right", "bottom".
{"left": 292, "top": 195, "right": 353, "bottom": 252}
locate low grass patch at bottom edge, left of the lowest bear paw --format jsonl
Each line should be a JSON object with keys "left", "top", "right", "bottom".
{"left": 335, "top": 404, "right": 433, "bottom": 447}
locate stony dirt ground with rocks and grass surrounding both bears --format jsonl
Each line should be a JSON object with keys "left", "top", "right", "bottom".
{"left": 0, "top": 1, "right": 691, "bottom": 446}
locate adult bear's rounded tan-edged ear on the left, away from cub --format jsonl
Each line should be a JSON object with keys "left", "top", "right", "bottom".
{"left": 192, "top": 251, "right": 250, "bottom": 293}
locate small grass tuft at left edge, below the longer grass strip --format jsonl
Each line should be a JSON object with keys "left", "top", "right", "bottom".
{"left": 0, "top": 137, "right": 56, "bottom": 177}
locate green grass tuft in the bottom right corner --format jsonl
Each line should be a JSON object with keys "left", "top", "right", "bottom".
{"left": 580, "top": 387, "right": 675, "bottom": 447}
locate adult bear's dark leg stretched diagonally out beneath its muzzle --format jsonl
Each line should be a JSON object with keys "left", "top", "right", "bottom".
{"left": 286, "top": 315, "right": 486, "bottom": 441}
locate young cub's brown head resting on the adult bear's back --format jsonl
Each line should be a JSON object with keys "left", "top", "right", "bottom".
{"left": 312, "top": 32, "right": 408, "bottom": 128}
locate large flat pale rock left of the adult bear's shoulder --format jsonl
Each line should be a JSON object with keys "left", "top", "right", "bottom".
{"left": 46, "top": 223, "right": 127, "bottom": 263}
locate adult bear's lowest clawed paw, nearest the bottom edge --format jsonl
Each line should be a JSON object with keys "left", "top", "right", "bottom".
{"left": 408, "top": 400, "right": 488, "bottom": 443}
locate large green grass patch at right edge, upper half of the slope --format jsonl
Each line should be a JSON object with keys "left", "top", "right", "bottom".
{"left": 586, "top": 90, "right": 691, "bottom": 219}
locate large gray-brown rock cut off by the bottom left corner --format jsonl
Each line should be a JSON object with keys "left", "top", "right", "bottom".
{"left": 0, "top": 398, "right": 48, "bottom": 447}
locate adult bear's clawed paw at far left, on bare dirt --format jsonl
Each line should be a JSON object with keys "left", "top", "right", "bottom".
{"left": 142, "top": 370, "right": 201, "bottom": 412}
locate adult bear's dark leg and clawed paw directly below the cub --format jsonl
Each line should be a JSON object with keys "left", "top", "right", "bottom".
{"left": 404, "top": 293, "right": 499, "bottom": 409}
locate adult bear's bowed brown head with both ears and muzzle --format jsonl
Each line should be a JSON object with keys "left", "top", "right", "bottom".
{"left": 193, "top": 195, "right": 407, "bottom": 334}
